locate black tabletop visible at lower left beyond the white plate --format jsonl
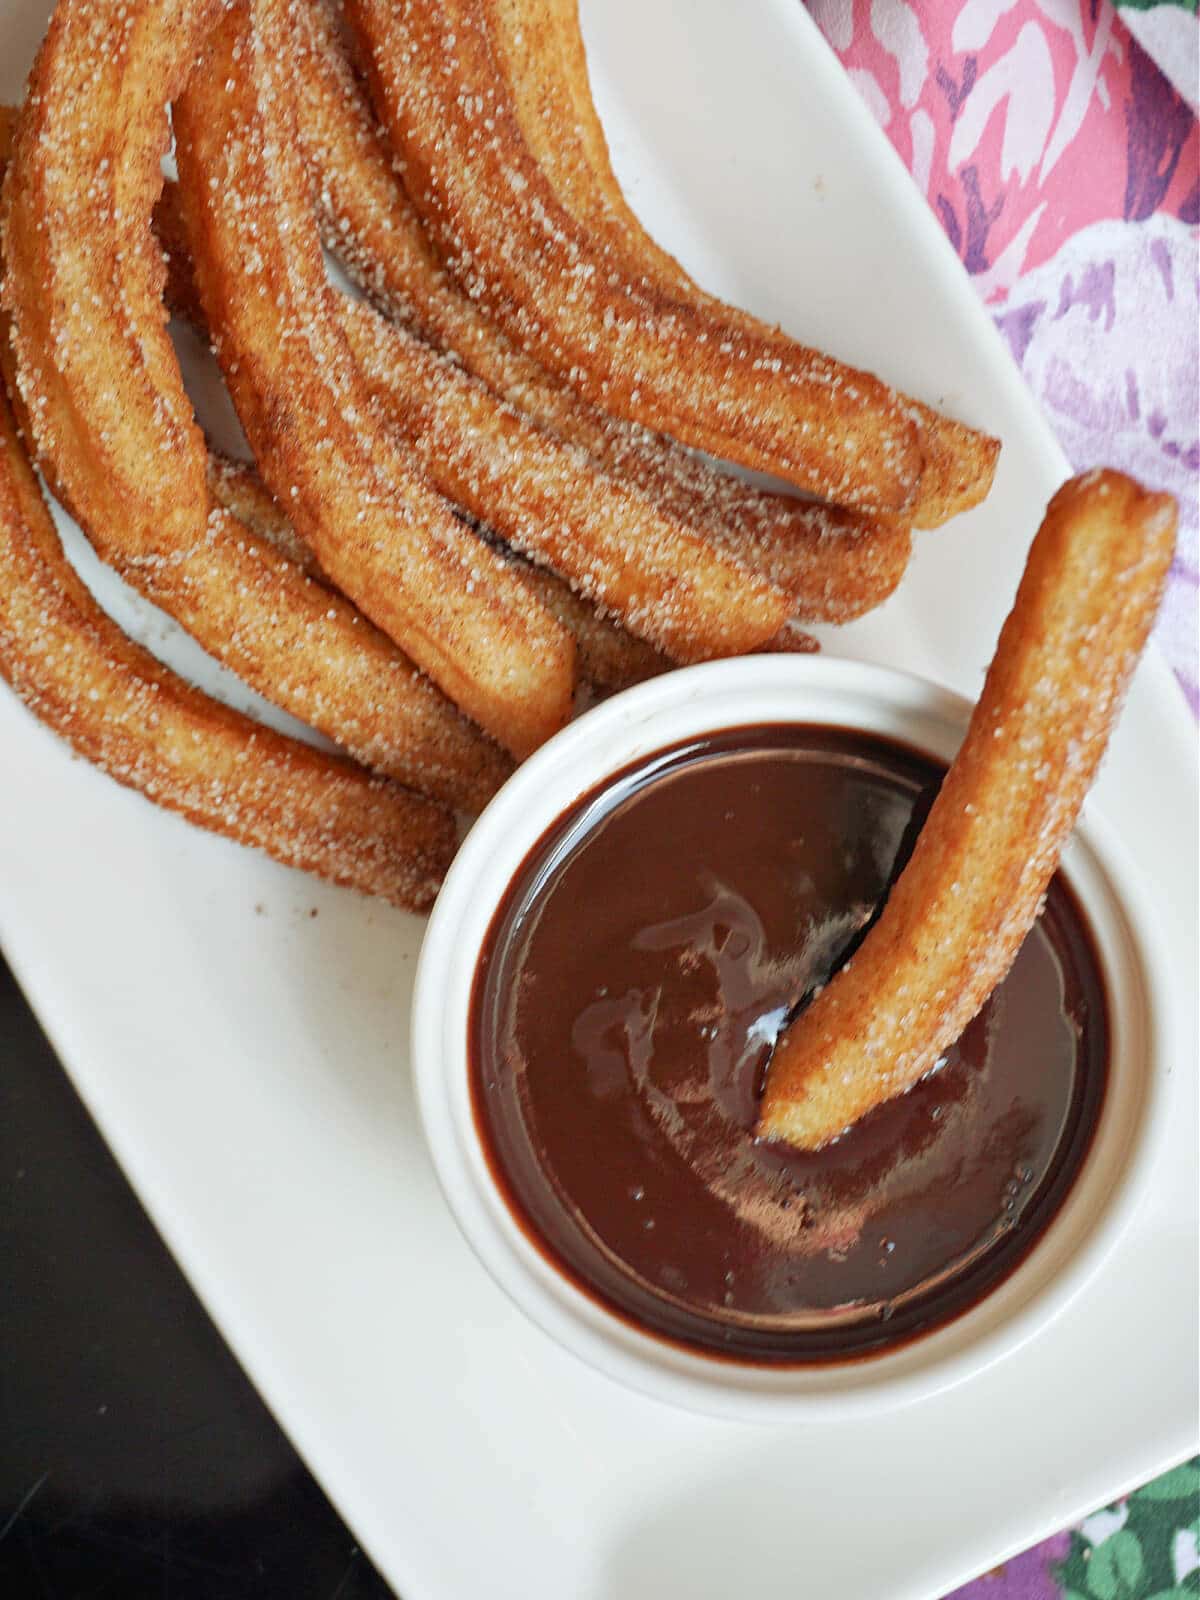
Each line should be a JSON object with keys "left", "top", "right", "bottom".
{"left": 0, "top": 960, "right": 390, "bottom": 1600}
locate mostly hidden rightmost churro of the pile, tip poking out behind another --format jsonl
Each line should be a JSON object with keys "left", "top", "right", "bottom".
{"left": 488, "top": 0, "right": 1000, "bottom": 528}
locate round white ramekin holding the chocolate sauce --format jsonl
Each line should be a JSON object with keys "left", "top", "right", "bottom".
{"left": 413, "top": 656, "right": 1171, "bottom": 1421}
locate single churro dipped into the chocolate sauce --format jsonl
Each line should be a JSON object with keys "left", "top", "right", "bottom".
{"left": 758, "top": 470, "right": 1176, "bottom": 1149}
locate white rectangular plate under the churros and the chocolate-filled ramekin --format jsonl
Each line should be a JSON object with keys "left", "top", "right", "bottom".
{"left": 0, "top": 0, "right": 1197, "bottom": 1600}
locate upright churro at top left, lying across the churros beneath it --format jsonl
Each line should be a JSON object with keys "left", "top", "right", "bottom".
{"left": 3, "top": 0, "right": 216, "bottom": 554}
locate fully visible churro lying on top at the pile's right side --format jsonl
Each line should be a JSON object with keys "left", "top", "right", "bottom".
{"left": 347, "top": 0, "right": 979, "bottom": 514}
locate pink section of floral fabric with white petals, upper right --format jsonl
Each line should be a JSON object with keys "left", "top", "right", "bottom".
{"left": 810, "top": 0, "right": 1200, "bottom": 291}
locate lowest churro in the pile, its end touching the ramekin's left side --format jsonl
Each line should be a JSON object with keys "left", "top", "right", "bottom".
{"left": 0, "top": 368, "right": 454, "bottom": 910}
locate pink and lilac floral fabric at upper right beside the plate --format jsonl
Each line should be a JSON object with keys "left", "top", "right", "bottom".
{"left": 808, "top": 0, "right": 1200, "bottom": 710}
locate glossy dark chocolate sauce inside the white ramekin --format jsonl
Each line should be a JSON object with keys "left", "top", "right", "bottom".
{"left": 470, "top": 726, "right": 1109, "bottom": 1363}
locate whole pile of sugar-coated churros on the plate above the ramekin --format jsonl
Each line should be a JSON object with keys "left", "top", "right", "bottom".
{"left": 0, "top": 0, "right": 998, "bottom": 907}
